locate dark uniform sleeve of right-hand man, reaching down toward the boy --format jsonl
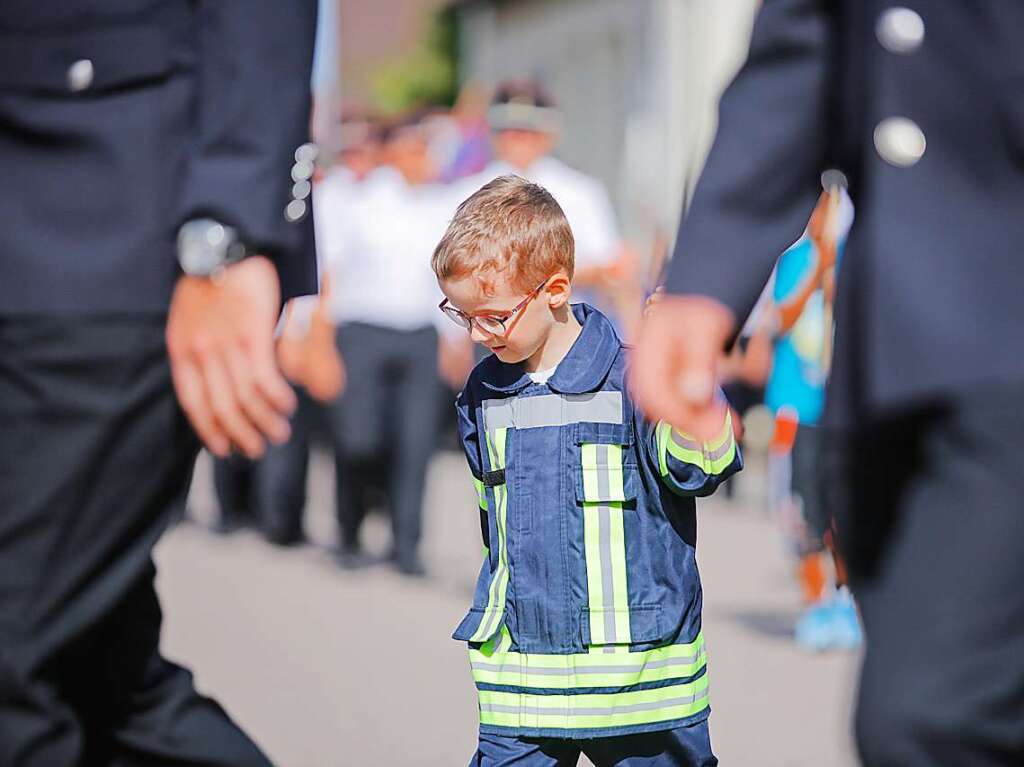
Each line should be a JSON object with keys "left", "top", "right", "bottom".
{"left": 666, "top": 0, "right": 835, "bottom": 325}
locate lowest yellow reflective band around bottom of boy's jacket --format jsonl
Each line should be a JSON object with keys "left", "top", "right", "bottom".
{"left": 479, "top": 675, "right": 708, "bottom": 729}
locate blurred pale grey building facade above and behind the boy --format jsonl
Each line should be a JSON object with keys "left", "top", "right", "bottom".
{"left": 454, "top": 0, "right": 759, "bottom": 266}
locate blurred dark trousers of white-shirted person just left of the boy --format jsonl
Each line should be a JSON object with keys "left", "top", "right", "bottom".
{"left": 332, "top": 323, "right": 441, "bottom": 560}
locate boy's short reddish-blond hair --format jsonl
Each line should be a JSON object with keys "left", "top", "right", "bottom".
{"left": 430, "top": 176, "right": 575, "bottom": 294}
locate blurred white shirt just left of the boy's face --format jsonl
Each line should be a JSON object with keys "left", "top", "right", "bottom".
{"left": 313, "top": 168, "right": 465, "bottom": 335}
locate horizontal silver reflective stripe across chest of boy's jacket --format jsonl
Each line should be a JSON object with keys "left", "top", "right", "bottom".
{"left": 483, "top": 391, "right": 623, "bottom": 431}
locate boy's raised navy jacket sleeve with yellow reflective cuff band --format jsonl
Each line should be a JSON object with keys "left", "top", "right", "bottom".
{"left": 637, "top": 401, "right": 743, "bottom": 498}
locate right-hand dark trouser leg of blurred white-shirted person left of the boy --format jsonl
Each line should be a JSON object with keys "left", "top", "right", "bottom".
{"left": 391, "top": 329, "right": 441, "bottom": 574}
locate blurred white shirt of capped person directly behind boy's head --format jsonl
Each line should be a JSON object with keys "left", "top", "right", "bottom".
{"left": 463, "top": 157, "right": 620, "bottom": 269}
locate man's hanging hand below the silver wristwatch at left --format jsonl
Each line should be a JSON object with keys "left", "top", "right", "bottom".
{"left": 167, "top": 256, "right": 296, "bottom": 458}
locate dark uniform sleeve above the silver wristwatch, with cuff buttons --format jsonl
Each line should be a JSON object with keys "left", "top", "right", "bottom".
{"left": 178, "top": 0, "right": 316, "bottom": 298}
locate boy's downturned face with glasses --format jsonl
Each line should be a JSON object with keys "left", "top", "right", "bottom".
{"left": 439, "top": 273, "right": 571, "bottom": 365}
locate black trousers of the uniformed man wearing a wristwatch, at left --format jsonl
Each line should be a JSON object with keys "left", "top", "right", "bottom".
{"left": 0, "top": 316, "right": 268, "bottom": 767}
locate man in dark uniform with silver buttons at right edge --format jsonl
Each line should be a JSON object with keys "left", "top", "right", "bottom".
{"left": 633, "top": 0, "right": 1024, "bottom": 767}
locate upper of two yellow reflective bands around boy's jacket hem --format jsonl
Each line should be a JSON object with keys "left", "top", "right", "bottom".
{"left": 469, "top": 632, "right": 708, "bottom": 689}
